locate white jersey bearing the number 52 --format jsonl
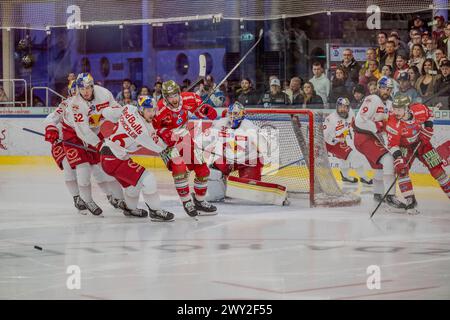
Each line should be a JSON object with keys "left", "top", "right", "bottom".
{"left": 63, "top": 85, "right": 123, "bottom": 146}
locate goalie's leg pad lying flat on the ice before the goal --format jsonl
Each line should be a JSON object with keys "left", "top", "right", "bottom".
{"left": 226, "top": 176, "right": 287, "bottom": 206}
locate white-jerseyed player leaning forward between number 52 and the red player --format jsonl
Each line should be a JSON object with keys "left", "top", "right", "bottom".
{"left": 100, "top": 96, "right": 174, "bottom": 221}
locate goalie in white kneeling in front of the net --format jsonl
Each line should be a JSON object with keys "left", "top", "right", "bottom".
{"left": 203, "top": 102, "right": 287, "bottom": 205}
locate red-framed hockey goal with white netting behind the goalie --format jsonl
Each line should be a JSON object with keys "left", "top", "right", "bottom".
{"left": 234, "top": 109, "right": 361, "bottom": 207}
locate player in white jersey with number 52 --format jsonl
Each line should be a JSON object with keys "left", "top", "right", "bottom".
{"left": 62, "top": 73, "right": 123, "bottom": 215}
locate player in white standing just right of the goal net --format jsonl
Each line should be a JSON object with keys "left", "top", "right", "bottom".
{"left": 323, "top": 98, "right": 373, "bottom": 185}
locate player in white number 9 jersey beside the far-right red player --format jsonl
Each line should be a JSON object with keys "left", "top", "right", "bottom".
{"left": 354, "top": 77, "right": 406, "bottom": 211}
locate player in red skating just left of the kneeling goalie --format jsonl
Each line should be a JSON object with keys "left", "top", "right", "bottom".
{"left": 153, "top": 80, "right": 217, "bottom": 217}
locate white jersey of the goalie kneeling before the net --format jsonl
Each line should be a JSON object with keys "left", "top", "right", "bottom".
{"left": 202, "top": 117, "right": 268, "bottom": 164}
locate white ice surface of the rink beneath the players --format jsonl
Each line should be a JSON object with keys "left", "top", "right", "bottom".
{"left": 0, "top": 165, "right": 450, "bottom": 300}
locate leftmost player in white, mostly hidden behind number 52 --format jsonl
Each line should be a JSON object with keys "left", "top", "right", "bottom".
{"left": 44, "top": 80, "right": 87, "bottom": 210}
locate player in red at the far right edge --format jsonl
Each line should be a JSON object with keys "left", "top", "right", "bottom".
{"left": 386, "top": 95, "right": 450, "bottom": 214}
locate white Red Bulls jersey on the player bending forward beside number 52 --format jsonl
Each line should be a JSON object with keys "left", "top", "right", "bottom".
{"left": 104, "top": 105, "right": 167, "bottom": 160}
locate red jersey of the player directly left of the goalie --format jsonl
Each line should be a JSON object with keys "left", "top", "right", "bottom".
{"left": 153, "top": 92, "right": 205, "bottom": 137}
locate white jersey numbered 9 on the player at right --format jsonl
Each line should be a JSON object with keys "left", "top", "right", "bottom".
{"left": 355, "top": 94, "right": 392, "bottom": 134}
